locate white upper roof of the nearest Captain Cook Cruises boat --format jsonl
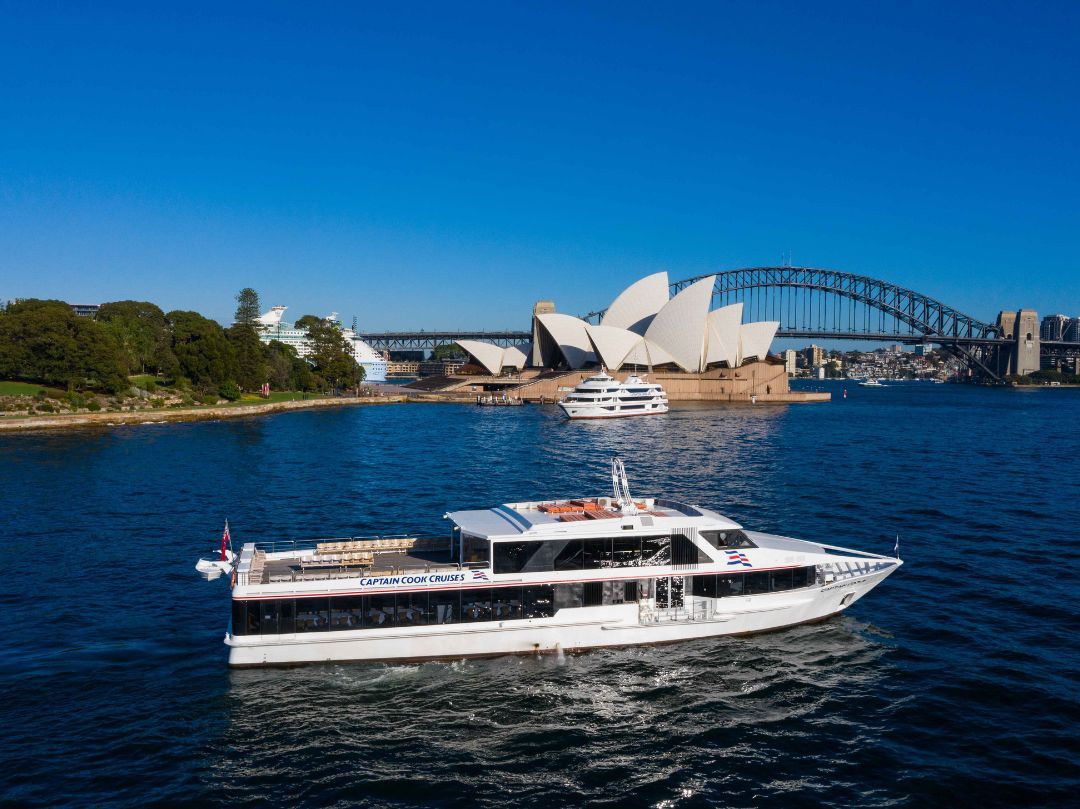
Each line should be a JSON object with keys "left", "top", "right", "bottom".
{"left": 446, "top": 497, "right": 741, "bottom": 538}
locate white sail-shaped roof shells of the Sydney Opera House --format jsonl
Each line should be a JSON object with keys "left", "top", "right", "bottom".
{"left": 457, "top": 272, "right": 780, "bottom": 376}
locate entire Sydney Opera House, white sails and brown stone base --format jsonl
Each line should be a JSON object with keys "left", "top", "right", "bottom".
{"left": 412, "top": 272, "right": 820, "bottom": 401}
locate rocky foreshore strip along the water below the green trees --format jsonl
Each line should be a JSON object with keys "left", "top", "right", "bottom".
{"left": 0, "top": 395, "right": 407, "bottom": 432}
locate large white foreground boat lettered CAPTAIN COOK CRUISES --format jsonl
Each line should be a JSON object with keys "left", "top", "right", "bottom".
{"left": 204, "top": 459, "right": 902, "bottom": 666}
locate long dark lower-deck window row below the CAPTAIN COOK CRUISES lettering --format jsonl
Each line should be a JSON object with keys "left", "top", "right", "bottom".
{"left": 232, "top": 580, "right": 652, "bottom": 635}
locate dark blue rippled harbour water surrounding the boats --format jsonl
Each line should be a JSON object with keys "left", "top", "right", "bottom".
{"left": 0, "top": 383, "right": 1080, "bottom": 807}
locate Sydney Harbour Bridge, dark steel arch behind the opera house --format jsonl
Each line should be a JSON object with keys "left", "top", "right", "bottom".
{"left": 360, "top": 267, "right": 1080, "bottom": 380}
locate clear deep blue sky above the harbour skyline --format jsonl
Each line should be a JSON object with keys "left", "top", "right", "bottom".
{"left": 0, "top": 0, "right": 1080, "bottom": 331}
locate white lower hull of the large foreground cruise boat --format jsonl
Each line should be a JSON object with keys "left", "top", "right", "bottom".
{"left": 226, "top": 566, "right": 896, "bottom": 668}
